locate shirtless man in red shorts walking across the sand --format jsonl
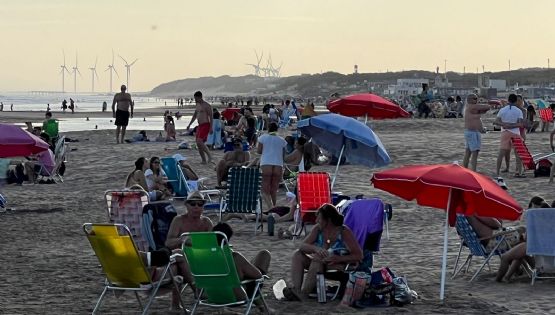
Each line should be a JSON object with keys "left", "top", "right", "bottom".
{"left": 187, "top": 91, "right": 212, "bottom": 164}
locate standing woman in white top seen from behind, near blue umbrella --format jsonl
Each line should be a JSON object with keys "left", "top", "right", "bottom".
{"left": 256, "top": 122, "right": 287, "bottom": 209}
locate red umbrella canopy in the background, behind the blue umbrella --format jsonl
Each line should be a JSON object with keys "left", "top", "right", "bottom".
{"left": 328, "top": 93, "right": 410, "bottom": 119}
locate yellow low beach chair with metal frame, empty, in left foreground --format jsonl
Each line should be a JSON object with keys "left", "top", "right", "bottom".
{"left": 83, "top": 223, "right": 185, "bottom": 314}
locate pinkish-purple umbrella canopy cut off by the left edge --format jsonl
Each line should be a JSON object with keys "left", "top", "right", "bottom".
{"left": 0, "top": 124, "right": 48, "bottom": 158}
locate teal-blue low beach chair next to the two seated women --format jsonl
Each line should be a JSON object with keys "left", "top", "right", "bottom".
{"left": 160, "top": 156, "right": 220, "bottom": 201}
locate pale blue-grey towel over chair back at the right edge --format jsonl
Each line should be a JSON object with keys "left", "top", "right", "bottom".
{"left": 526, "top": 208, "right": 555, "bottom": 256}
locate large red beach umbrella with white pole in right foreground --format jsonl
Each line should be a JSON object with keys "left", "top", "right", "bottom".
{"left": 371, "top": 164, "right": 523, "bottom": 300}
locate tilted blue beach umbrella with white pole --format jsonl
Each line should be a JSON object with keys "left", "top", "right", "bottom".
{"left": 297, "top": 114, "right": 391, "bottom": 188}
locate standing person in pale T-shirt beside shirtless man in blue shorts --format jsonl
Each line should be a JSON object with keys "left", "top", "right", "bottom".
{"left": 493, "top": 94, "right": 524, "bottom": 181}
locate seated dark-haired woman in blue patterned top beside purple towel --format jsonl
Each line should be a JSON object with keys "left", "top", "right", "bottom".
{"left": 283, "top": 204, "right": 362, "bottom": 301}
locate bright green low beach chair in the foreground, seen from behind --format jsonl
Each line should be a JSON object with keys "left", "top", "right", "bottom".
{"left": 181, "top": 232, "right": 268, "bottom": 314}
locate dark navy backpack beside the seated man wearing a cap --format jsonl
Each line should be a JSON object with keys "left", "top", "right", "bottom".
{"left": 143, "top": 202, "right": 177, "bottom": 250}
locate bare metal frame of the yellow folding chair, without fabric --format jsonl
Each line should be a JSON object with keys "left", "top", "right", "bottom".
{"left": 83, "top": 223, "right": 185, "bottom": 315}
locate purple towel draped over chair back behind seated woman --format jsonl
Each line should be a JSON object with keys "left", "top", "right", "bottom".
{"left": 345, "top": 198, "right": 384, "bottom": 250}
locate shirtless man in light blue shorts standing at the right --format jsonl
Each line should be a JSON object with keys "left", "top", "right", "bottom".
{"left": 463, "top": 94, "right": 490, "bottom": 171}
